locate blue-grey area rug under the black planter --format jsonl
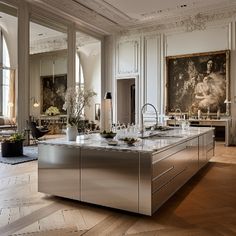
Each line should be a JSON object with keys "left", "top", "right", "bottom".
{"left": 0, "top": 146, "right": 38, "bottom": 165}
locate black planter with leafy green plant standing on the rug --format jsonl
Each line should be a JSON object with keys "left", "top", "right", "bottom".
{"left": 0, "top": 133, "right": 24, "bottom": 157}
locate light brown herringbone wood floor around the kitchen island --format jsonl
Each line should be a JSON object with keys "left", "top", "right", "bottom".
{"left": 0, "top": 143, "right": 236, "bottom": 236}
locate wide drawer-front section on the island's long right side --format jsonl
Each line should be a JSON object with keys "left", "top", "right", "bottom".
{"left": 152, "top": 137, "right": 198, "bottom": 213}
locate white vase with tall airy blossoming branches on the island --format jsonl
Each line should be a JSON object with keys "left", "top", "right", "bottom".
{"left": 63, "top": 87, "right": 97, "bottom": 141}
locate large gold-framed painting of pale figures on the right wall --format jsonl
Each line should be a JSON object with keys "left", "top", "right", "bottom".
{"left": 166, "top": 50, "right": 230, "bottom": 114}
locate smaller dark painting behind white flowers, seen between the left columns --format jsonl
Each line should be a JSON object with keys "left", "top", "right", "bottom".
{"left": 40, "top": 74, "right": 67, "bottom": 114}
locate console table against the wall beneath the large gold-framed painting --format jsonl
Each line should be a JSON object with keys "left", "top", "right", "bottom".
{"left": 167, "top": 118, "right": 231, "bottom": 146}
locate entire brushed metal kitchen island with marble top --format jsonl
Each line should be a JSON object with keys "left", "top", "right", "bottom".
{"left": 38, "top": 127, "right": 214, "bottom": 215}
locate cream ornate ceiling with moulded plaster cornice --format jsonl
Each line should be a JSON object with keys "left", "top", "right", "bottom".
{"left": 32, "top": 0, "right": 236, "bottom": 34}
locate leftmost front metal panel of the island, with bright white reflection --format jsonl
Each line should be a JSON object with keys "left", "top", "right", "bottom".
{"left": 38, "top": 144, "right": 80, "bottom": 200}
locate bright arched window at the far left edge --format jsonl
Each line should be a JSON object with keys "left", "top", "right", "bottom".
{"left": 0, "top": 32, "right": 10, "bottom": 116}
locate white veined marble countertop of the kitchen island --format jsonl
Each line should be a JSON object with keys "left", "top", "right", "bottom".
{"left": 39, "top": 127, "right": 215, "bottom": 153}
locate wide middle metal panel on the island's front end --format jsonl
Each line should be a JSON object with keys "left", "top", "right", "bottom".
{"left": 81, "top": 147, "right": 139, "bottom": 212}
